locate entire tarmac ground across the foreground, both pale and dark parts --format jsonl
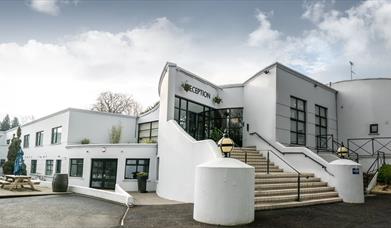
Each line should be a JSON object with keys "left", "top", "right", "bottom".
{"left": 0, "top": 194, "right": 391, "bottom": 228}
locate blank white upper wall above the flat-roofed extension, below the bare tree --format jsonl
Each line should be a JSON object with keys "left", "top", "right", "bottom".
{"left": 67, "top": 109, "right": 137, "bottom": 144}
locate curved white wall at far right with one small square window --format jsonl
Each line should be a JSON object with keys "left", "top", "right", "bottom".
{"left": 332, "top": 79, "right": 391, "bottom": 142}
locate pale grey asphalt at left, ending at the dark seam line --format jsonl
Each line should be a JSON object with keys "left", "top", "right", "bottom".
{"left": 0, "top": 194, "right": 126, "bottom": 228}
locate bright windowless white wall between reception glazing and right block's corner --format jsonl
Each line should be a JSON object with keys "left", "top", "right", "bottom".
{"left": 243, "top": 67, "right": 276, "bottom": 146}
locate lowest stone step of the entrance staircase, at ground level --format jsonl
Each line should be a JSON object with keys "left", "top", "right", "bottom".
{"left": 255, "top": 197, "right": 342, "bottom": 210}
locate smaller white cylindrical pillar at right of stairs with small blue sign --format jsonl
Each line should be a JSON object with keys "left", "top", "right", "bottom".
{"left": 329, "top": 159, "right": 364, "bottom": 203}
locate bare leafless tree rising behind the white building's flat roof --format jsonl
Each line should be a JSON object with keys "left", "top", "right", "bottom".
{"left": 92, "top": 91, "right": 142, "bottom": 116}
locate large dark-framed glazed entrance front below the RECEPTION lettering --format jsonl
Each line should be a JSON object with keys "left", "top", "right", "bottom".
{"left": 174, "top": 97, "right": 243, "bottom": 146}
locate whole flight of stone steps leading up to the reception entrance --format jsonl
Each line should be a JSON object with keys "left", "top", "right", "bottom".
{"left": 231, "top": 147, "right": 342, "bottom": 210}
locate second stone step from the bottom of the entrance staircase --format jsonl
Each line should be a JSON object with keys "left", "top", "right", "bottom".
{"left": 255, "top": 192, "right": 338, "bottom": 204}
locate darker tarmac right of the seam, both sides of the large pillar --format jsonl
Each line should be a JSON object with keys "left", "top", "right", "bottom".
{"left": 125, "top": 195, "right": 391, "bottom": 228}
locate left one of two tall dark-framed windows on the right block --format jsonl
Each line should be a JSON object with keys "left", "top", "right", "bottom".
{"left": 289, "top": 96, "right": 307, "bottom": 146}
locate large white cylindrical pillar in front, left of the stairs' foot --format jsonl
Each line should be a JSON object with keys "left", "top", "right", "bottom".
{"left": 193, "top": 158, "right": 255, "bottom": 226}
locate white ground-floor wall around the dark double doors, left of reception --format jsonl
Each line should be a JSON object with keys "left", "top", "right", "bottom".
{"left": 64, "top": 144, "right": 157, "bottom": 191}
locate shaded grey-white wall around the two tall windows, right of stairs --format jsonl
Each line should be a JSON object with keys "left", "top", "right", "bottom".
{"left": 276, "top": 65, "right": 337, "bottom": 148}
